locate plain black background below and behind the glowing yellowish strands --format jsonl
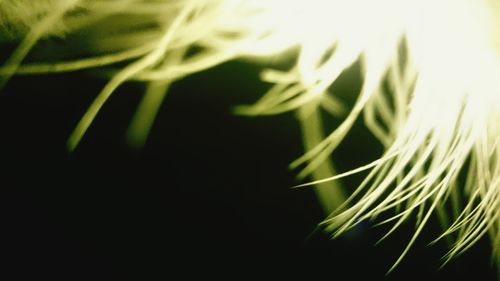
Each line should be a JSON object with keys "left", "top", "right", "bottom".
{"left": 0, "top": 59, "right": 496, "bottom": 280}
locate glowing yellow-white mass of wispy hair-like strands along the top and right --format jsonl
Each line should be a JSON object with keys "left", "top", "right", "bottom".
{"left": 0, "top": 0, "right": 500, "bottom": 270}
